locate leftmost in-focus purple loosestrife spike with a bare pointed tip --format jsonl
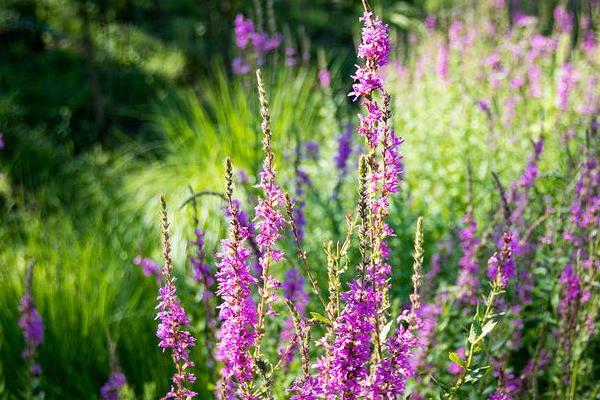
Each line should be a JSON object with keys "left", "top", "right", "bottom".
{"left": 156, "top": 197, "right": 196, "bottom": 400}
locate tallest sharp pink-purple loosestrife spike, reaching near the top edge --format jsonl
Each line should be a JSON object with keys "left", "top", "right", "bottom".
{"left": 349, "top": 9, "right": 403, "bottom": 307}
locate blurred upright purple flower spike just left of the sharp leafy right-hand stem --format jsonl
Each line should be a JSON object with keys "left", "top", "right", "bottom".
{"left": 458, "top": 213, "right": 480, "bottom": 305}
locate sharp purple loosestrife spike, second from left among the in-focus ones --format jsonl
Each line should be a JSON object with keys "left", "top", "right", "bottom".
{"left": 217, "top": 159, "right": 257, "bottom": 399}
